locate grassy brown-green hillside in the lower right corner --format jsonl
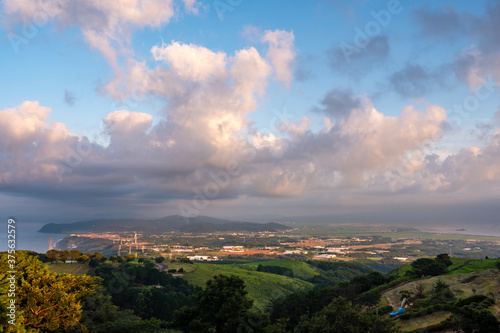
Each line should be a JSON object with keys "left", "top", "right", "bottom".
{"left": 378, "top": 258, "right": 500, "bottom": 332}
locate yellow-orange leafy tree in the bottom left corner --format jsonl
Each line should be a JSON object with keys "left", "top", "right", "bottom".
{"left": 0, "top": 251, "right": 99, "bottom": 332}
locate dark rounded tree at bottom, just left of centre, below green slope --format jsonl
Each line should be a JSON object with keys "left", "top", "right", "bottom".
{"left": 175, "top": 275, "right": 253, "bottom": 333}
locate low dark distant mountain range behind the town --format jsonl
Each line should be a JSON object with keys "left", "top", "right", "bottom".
{"left": 38, "top": 215, "right": 291, "bottom": 234}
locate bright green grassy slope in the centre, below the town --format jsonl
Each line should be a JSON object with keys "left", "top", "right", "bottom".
{"left": 184, "top": 263, "right": 313, "bottom": 309}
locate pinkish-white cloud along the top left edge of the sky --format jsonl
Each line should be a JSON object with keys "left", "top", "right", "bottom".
{"left": 4, "top": 0, "right": 199, "bottom": 69}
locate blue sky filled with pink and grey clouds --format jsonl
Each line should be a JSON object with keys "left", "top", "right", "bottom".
{"left": 0, "top": 0, "right": 500, "bottom": 226}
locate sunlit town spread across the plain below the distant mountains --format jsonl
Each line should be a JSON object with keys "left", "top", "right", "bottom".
{"left": 56, "top": 226, "right": 500, "bottom": 268}
